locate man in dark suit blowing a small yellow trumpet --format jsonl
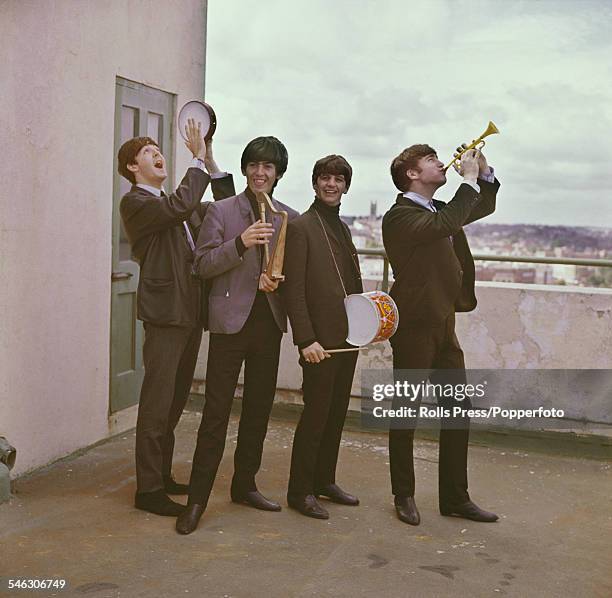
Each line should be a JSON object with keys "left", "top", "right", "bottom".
{"left": 382, "top": 145, "right": 499, "bottom": 525}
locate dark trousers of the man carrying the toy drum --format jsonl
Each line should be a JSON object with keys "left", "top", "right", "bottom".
{"left": 288, "top": 351, "right": 357, "bottom": 495}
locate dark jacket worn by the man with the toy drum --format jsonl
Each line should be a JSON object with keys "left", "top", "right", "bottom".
{"left": 282, "top": 206, "right": 363, "bottom": 349}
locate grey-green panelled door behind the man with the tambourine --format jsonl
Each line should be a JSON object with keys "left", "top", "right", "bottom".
{"left": 110, "top": 77, "right": 175, "bottom": 413}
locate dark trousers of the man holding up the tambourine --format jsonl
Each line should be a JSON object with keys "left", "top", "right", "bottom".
{"left": 136, "top": 322, "right": 202, "bottom": 492}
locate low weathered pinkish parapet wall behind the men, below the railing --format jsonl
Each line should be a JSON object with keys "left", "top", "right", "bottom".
{"left": 196, "top": 282, "right": 612, "bottom": 431}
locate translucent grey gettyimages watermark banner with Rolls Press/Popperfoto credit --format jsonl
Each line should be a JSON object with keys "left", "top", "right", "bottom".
{"left": 361, "top": 370, "right": 612, "bottom": 430}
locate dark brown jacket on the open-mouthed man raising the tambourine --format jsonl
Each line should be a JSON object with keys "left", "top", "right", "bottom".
{"left": 119, "top": 168, "right": 234, "bottom": 326}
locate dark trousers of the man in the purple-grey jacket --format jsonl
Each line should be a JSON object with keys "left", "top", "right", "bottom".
{"left": 189, "top": 309, "right": 282, "bottom": 504}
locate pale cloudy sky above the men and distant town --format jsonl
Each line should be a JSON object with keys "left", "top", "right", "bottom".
{"left": 205, "top": 0, "right": 612, "bottom": 228}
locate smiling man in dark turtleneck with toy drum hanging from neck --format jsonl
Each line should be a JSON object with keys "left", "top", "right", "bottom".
{"left": 283, "top": 155, "right": 363, "bottom": 519}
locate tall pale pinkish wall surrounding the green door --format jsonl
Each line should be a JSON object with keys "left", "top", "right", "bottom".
{"left": 0, "top": 0, "right": 206, "bottom": 474}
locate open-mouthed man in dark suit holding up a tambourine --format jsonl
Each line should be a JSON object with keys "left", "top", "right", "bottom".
{"left": 118, "top": 122, "right": 234, "bottom": 516}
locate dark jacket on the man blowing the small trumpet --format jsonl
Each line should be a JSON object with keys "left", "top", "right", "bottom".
{"left": 382, "top": 179, "right": 500, "bottom": 327}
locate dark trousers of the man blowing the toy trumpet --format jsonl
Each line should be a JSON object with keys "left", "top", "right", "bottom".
{"left": 389, "top": 314, "right": 471, "bottom": 507}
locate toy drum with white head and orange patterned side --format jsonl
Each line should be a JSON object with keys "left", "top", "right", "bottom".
{"left": 344, "top": 291, "right": 399, "bottom": 347}
